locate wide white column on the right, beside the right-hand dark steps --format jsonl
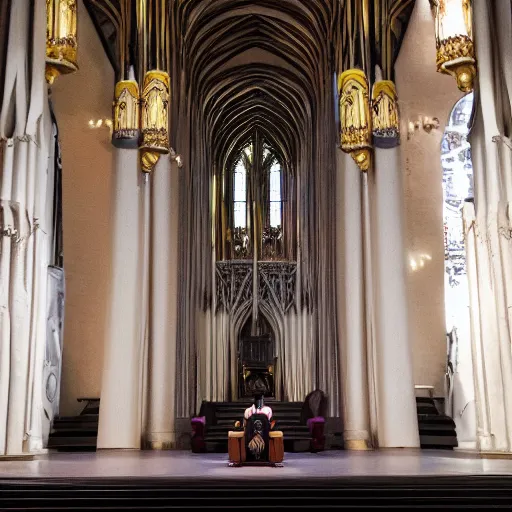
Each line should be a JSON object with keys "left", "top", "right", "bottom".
{"left": 372, "top": 147, "right": 419, "bottom": 448}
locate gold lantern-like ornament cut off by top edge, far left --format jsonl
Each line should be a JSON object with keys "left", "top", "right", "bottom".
{"left": 46, "top": 0, "right": 78, "bottom": 85}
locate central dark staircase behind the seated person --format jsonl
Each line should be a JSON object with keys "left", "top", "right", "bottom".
{"left": 199, "top": 400, "right": 311, "bottom": 453}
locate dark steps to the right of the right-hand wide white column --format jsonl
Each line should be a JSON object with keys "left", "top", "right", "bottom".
{"left": 416, "top": 397, "right": 458, "bottom": 450}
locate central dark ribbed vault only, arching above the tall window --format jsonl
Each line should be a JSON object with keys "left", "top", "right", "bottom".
{"left": 173, "top": 0, "right": 338, "bottom": 172}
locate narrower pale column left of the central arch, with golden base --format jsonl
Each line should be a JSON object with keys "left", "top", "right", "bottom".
{"left": 148, "top": 157, "right": 180, "bottom": 450}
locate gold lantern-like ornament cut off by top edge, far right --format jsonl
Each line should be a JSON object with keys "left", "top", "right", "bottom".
{"left": 431, "top": 0, "right": 476, "bottom": 92}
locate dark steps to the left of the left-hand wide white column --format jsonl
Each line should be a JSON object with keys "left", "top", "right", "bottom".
{"left": 48, "top": 398, "right": 100, "bottom": 452}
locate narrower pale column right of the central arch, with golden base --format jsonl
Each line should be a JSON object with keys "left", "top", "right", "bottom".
{"left": 336, "top": 150, "right": 369, "bottom": 450}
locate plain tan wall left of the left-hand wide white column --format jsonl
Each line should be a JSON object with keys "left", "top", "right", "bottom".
{"left": 52, "top": 0, "right": 115, "bottom": 414}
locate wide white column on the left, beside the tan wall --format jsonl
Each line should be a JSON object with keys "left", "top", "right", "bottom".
{"left": 98, "top": 149, "right": 147, "bottom": 449}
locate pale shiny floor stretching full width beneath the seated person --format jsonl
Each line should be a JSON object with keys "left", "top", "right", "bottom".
{"left": 0, "top": 450, "right": 512, "bottom": 481}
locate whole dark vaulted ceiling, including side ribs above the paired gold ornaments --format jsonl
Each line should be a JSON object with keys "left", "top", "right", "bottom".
{"left": 84, "top": 0, "right": 415, "bottom": 167}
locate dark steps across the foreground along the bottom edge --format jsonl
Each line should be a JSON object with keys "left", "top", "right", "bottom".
{"left": 0, "top": 474, "right": 512, "bottom": 511}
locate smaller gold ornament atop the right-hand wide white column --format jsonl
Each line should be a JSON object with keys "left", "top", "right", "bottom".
{"left": 372, "top": 80, "right": 400, "bottom": 148}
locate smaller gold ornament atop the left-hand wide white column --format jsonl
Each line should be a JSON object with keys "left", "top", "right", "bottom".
{"left": 112, "top": 80, "right": 140, "bottom": 149}
